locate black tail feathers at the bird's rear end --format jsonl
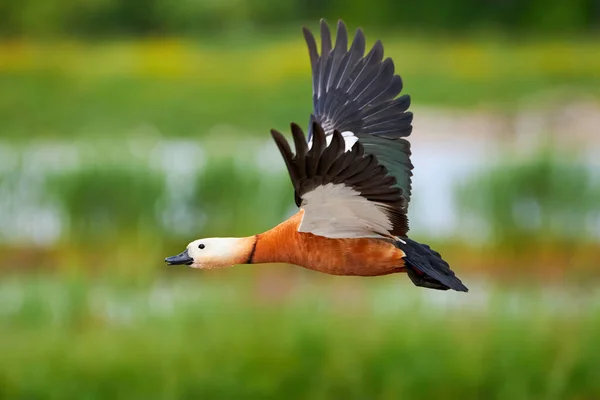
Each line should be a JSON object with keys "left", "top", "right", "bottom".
{"left": 396, "top": 238, "right": 469, "bottom": 292}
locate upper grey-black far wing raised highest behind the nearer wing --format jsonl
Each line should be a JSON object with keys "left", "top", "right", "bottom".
{"left": 303, "top": 20, "right": 413, "bottom": 202}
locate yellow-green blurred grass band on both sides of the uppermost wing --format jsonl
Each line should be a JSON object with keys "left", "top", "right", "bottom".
{"left": 0, "top": 33, "right": 600, "bottom": 139}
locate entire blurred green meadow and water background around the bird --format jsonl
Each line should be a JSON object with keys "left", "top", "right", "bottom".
{"left": 0, "top": 0, "right": 600, "bottom": 400}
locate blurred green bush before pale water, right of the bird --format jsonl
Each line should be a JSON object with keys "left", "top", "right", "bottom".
{"left": 457, "top": 147, "right": 600, "bottom": 250}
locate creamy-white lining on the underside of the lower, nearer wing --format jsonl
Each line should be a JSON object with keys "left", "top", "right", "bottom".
{"left": 298, "top": 183, "right": 393, "bottom": 239}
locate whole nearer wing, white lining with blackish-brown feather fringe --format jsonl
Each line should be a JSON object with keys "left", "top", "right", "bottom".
{"left": 271, "top": 122, "right": 408, "bottom": 238}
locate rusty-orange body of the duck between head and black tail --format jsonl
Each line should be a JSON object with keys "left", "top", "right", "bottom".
{"left": 252, "top": 210, "right": 405, "bottom": 276}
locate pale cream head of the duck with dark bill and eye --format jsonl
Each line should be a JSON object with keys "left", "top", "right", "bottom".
{"left": 165, "top": 236, "right": 256, "bottom": 269}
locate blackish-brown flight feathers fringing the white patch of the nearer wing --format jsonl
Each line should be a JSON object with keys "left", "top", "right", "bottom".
{"left": 271, "top": 122, "right": 408, "bottom": 236}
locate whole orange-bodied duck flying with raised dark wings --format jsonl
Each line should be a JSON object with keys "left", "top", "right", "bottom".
{"left": 165, "top": 20, "right": 468, "bottom": 292}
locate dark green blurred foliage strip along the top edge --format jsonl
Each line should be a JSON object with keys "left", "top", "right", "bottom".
{"left": 0, "top": 0, "right": 600, "bottom": 36}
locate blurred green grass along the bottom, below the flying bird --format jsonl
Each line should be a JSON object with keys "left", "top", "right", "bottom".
{"left": 0, "top": 271, "right": 600, "bottom": 400}
